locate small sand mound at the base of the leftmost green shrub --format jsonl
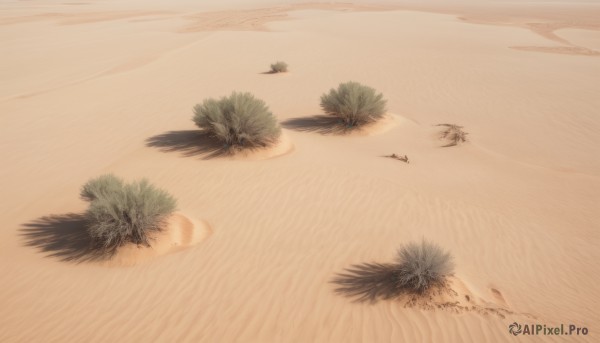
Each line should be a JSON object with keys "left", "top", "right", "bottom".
{"left": 101, "top": 213, "right": 212, "bottom": 267}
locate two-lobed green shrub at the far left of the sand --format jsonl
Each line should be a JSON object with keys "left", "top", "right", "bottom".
{"left": 81, "top": 174, "right": 177, "bottom": 251}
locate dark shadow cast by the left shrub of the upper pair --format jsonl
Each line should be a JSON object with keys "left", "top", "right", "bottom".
{"left": 146, "top": 130, "right": 230, "bottom": 160}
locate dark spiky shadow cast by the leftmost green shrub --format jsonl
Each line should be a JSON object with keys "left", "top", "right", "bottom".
{"left": 20, "top": 213, "right": 110, "bottom": 262}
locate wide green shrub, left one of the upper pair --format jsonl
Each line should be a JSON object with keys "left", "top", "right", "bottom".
{"left": 193, "top": 92, "right": 281, "bottom": 147}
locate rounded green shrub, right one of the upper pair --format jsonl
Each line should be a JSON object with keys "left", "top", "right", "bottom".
{"left": 321, "top": 81, "right": 387, "bottom": 127}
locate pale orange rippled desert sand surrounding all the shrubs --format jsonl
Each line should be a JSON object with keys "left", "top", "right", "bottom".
{"left": 0, "top": 0, "right": 600, "bottom": 342}
